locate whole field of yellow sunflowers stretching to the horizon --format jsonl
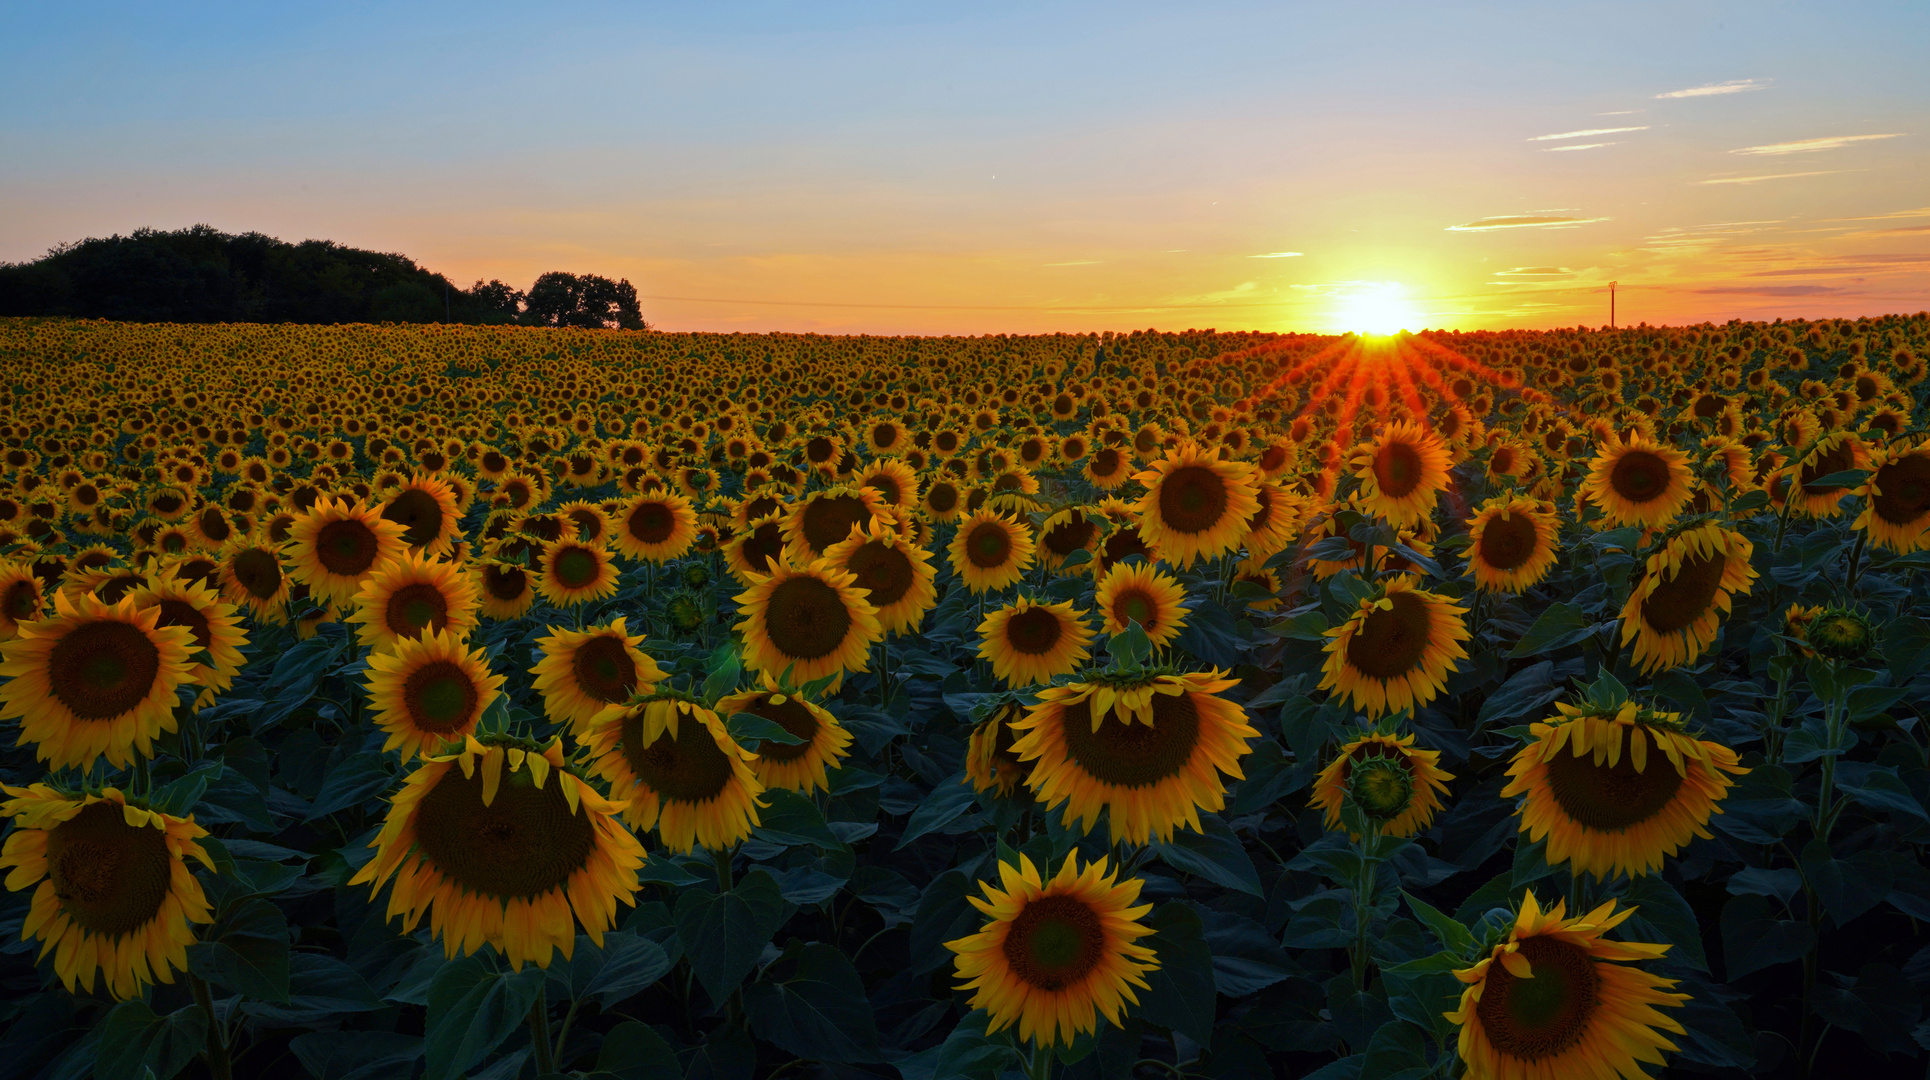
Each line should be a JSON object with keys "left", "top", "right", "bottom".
{"left": 0, "top": 314, "right": 1930, "bottom": 1080}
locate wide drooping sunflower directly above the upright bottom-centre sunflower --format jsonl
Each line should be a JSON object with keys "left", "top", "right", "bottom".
{"left": 1011, "top": 671, "right": 1260, "bottom": 843}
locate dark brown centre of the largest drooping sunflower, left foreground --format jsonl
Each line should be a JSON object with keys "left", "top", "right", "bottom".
{"left": 415, "top": 768, "right": 596, "bottom": 901}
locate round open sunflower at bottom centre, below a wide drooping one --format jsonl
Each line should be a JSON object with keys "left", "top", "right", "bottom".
{"left": 946, "top": 852, "right": 1160, "bottom": 1047}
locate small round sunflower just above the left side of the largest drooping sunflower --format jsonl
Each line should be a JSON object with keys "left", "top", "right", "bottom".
{"left": 365, "top": 631, "right": 504, "bottom": 762}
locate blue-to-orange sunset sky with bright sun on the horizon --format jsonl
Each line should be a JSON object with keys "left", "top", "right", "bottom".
{"left": 0, "top": 0, "right": 1930, "bottom": 334}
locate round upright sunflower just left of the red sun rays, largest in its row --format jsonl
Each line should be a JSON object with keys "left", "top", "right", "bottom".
{"left": 1133, "top": 442, "right": 1260, "bottom": 567}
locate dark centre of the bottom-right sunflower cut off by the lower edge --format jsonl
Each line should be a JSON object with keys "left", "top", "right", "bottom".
{"left": 1475, "top": 937, "right": 1602, "bottom": 1061}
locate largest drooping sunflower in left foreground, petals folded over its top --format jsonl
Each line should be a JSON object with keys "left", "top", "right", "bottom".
{"left": 349, "top": 735, "right": 643, "bottom": 970}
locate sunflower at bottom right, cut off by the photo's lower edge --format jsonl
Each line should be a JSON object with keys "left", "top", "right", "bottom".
{"left": 1446, "top": 891, "right": 1689, "bottom": 1080}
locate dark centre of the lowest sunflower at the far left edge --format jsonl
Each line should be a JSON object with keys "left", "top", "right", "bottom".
{"left": 46, "top": 802, "right": 174, "bottom": 937}
